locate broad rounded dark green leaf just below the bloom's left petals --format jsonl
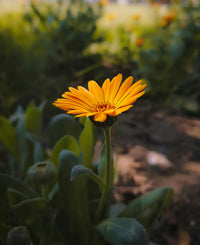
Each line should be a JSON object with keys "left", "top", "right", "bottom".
{"left": 49, "top": 114, "right": 81, "bottom": 148}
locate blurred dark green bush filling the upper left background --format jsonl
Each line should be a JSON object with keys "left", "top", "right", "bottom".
{"left": 0, "top": 1, "right": 101, "bottom": 115}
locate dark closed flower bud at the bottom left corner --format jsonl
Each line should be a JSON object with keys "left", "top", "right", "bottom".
{"left": 7, "top": 226, "right": 32, "bottom": 245}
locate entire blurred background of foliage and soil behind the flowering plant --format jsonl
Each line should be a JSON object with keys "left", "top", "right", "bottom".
{"left": 0, "top": 0, "right": 200, "bottom": 245}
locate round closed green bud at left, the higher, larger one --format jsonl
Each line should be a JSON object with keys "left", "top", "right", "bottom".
{"left": 28, "top": 161, "right": 56, "bottom": 185}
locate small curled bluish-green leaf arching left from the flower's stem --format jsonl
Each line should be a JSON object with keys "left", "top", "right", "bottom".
{"left": 71, "top": 164, "right": 105, "bottom": 189}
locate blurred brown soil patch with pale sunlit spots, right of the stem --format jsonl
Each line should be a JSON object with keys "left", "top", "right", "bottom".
{"left": 109, "top": 102, "right": 200, "bottom": 245}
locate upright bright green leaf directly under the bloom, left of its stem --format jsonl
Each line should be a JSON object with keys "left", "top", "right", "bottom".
{"left": 79, "top": 118, "right": 95, "bottom": 168}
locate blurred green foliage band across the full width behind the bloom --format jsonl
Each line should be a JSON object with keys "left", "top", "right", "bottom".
{"left": 0, "top": 1, "right": 200, "bottom": 115}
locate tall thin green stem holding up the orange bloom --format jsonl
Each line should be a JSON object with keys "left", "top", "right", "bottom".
{"left": 95, "top": 127, "right": 113, "bottom": 222}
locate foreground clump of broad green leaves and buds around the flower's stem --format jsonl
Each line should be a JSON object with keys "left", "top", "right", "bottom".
{"left": 0, "top": 103, "right": 172, "bottom": 245}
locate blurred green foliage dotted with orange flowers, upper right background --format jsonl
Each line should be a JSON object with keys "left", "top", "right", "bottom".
{"left": 97, "top": 4, "right": 200, "bottom": 115}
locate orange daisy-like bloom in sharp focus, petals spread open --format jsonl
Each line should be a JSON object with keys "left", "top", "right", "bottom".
{"left": 53, "top": 74, "right": 146, "bottom": 122}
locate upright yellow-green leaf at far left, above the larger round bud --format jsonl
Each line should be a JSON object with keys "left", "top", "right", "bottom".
{"left": 25, "top": 103, "right": 42, "bottom": 136}
